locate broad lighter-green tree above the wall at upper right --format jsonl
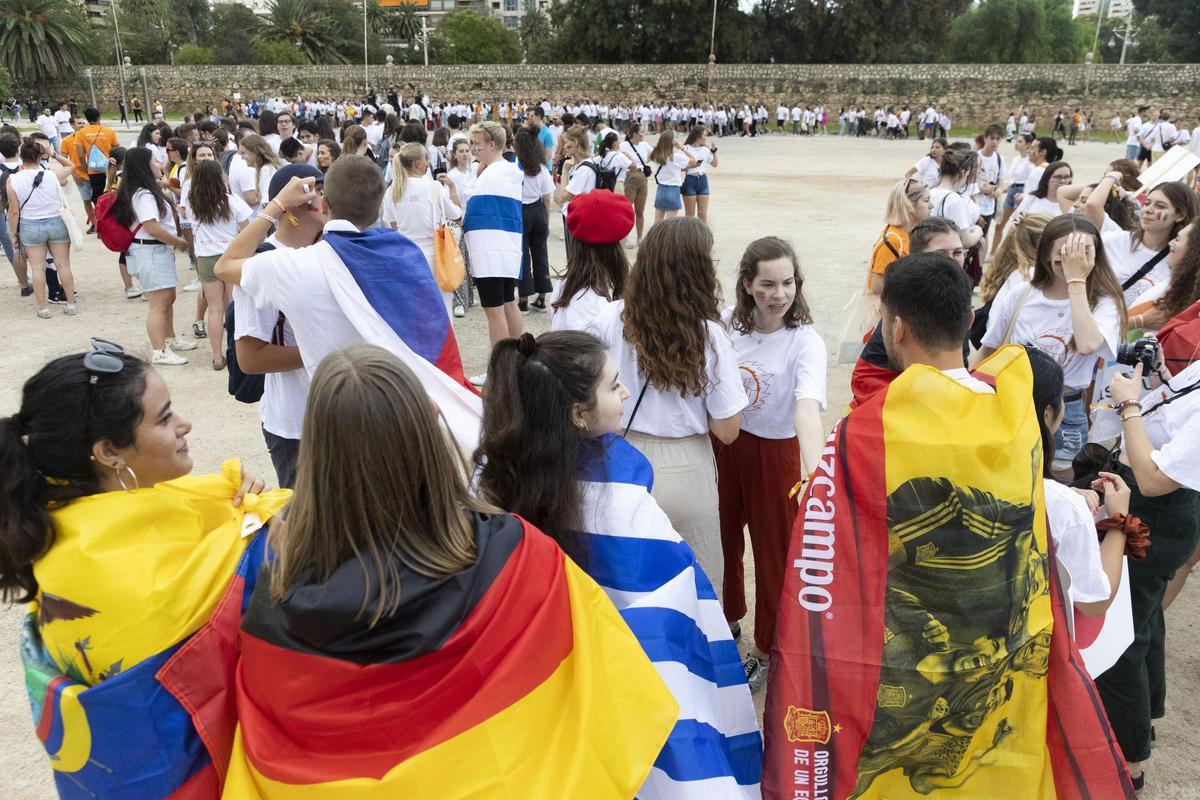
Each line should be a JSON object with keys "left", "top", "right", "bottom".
{"left": 943, "top": 0, "right": 1094, "bottom": 64}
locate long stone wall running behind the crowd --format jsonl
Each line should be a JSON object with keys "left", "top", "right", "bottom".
{"left": 55, "top": 64, "right": 1200, "bottom": 126}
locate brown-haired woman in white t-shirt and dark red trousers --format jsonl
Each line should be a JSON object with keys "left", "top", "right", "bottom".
{"left": 714, "top": 235, "right": 825, "bottom": 691}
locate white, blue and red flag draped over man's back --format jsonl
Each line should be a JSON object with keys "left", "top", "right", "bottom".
{"left": 321, "top": 228, "right": 484, "bottom": 452}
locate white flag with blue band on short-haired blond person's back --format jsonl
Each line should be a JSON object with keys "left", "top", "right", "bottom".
{"left": 462, "top": 160, "right": 524, "bottom": 278}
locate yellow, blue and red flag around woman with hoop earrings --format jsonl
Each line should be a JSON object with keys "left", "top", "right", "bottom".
{"left": 22, "top": 461, "right": 290, "bottom": 800}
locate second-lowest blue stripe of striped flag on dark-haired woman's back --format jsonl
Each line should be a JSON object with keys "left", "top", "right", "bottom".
{"left": 620, "top": 608, "right": 746, "bottom": 686}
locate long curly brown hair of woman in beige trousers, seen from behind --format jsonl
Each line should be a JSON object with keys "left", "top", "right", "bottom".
{"left": 622, "top": 217, "right": 721, "bottom": 397}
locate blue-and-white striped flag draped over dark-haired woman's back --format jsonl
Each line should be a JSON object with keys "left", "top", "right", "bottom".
{"left": 581, "top": 435, "right": 762, "bottom": 800}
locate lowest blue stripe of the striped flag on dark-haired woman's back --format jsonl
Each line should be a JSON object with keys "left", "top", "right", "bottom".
{"left": 654, "top": 720, "right": 762, "bottom": 786}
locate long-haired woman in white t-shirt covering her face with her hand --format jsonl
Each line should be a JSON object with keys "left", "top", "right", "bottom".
{"left": 972, "top": 213, "right": 1126, "bottom": 469}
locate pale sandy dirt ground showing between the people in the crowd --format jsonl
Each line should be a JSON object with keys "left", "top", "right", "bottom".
{"left": 0, "top": 136, "right": 1200, "bottom": 800}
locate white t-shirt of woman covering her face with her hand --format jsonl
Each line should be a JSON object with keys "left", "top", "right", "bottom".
{"left": 983, "top": 285, "right": 1121, "bottom": 390}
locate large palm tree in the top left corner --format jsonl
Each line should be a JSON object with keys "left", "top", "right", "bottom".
{"left": 0, "top": 0, "right": 89, "bottom": 95}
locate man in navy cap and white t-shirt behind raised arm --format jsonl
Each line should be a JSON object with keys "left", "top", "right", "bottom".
{"left": 226, "top": 164, "right": 325, "bottom": 489}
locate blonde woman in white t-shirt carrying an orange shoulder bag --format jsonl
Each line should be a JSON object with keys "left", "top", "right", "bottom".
{"left": 383, "top": 142, "right": 462, "bottom": 313}
